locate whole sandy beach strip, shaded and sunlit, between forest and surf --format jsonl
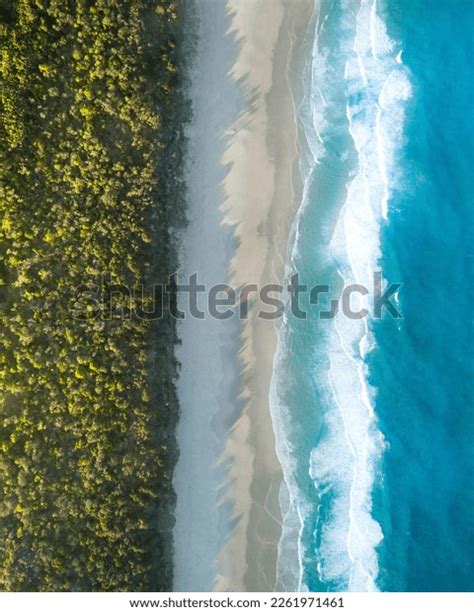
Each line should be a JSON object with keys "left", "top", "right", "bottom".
{"left": 174, "top": 0, "right": 313, "bottom": 591}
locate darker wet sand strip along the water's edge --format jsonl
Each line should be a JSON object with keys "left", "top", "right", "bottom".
{"left": 226, "top": 1, "right": 313, "bottom": 591}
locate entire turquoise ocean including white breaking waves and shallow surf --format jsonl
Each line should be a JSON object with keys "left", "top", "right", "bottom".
{"left": 271, "top": 0, "right": 474, "bottom": 591}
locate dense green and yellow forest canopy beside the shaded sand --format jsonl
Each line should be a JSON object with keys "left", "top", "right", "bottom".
{"left": 0, "top": 0, "right": 186, "bottom": 590}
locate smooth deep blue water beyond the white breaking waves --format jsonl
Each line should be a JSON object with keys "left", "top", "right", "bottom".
{"left": 370, "top": 0, "right": 474, "bottom": 591}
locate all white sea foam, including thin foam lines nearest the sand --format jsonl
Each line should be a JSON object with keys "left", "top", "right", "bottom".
{"left": 271, "top": 0, "right": 411, "bottom": 591}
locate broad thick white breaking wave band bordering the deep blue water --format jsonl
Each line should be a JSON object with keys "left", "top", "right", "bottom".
{"left": 311, "top": 0, "right": 410, "bottom": 591}
